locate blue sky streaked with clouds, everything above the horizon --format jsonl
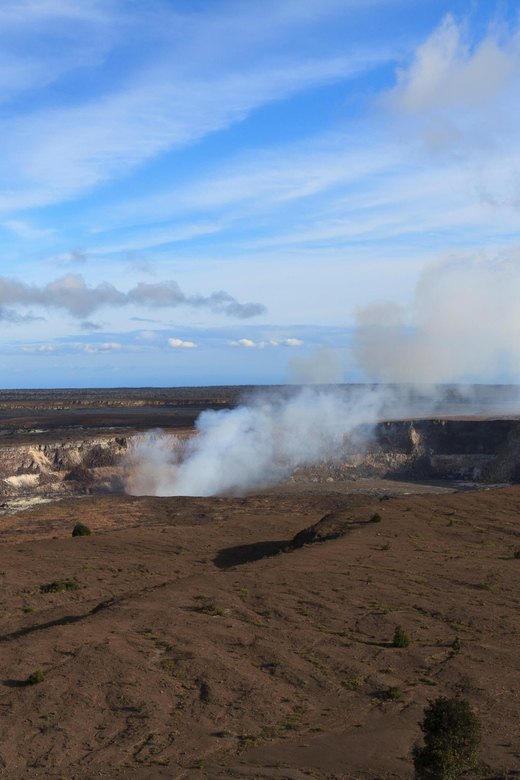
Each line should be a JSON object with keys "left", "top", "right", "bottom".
{"left": 0, "top": 0, "right": 520, "bottom": 388}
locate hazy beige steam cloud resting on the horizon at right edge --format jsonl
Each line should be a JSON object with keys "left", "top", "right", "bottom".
{"left": 354, "top": 255, "right": 520, "bottom": 382}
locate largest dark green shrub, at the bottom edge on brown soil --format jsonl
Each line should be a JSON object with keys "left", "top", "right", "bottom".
{"left": 413, "top": 696, "right": 482, "bottom": 780}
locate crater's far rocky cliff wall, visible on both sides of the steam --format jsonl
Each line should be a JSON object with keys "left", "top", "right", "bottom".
{"left": 0, "top": 419, "right": 520, "bottom": 497}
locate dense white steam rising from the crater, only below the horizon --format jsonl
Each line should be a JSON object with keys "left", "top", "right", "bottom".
{"left": 127, "top": 387, "right": 385, "bottom": 496}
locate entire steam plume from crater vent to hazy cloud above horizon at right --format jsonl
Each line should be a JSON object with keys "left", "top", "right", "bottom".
{"left": 127, "top": 251, "right": 520, "bottom": 496}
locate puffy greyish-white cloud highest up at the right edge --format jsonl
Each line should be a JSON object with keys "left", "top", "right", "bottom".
{"left": 382, "top": 15, "right": 520, "bottom": 159}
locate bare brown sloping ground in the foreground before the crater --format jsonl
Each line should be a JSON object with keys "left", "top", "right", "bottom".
{"left": 0, "top": 487, "right": 520, "bottom": 780}
